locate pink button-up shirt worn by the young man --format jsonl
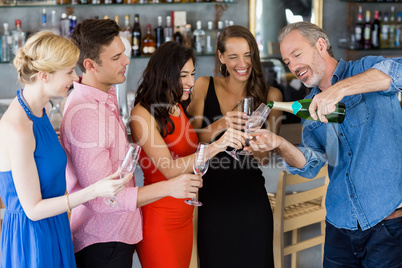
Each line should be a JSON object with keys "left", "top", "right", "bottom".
{"left": 60, "top": 82, "right": 142, "bottom": 252}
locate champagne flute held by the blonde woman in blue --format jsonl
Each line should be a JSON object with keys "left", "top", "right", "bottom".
{"left": 103, "top": 143, "right": 141, "bottom": 207}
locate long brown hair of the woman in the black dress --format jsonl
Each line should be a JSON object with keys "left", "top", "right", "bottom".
{"left": 216, "top": 25, "right": 269, "bottom": 107}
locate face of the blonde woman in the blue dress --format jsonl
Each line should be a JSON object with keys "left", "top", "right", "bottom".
{"left": 46, "top": 65, "right": 78, "bottom": 97}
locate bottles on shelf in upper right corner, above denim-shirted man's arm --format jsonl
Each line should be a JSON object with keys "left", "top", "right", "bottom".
{"left": 338, "top": 0, "right": 402, "bottom": 51}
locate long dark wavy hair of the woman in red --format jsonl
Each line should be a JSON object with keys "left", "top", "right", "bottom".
{"left": 134, "top": 41, "right": 195, "bottom": 137}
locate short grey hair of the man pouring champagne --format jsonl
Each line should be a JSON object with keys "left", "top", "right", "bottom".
{"left": 278, "top": 21, "right": 334, "bottom": 57}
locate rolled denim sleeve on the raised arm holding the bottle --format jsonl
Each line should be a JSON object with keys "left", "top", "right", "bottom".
{"left": 372, "top": 58, "right": 402, "bottom": 93}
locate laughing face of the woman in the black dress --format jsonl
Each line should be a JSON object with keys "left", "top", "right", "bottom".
{"left": 218, "top": 37, "right": 252, "bottom": 81}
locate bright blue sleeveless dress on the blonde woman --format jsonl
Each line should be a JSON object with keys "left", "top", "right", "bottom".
{"left": 0, "top": 90, "right": 76, "bottom": 268}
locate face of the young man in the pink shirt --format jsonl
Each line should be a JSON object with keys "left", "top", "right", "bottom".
{"left": 94, "top": 36, "right": 130, "bottom": 91}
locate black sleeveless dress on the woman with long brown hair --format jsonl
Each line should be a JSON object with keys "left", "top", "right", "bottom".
{"left": 198, "top": 77, "right": 273, "bottom": 268}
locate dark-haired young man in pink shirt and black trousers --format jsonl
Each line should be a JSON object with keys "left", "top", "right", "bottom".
{"left": 60, "top": 19, "right": 202, "bottom": 268}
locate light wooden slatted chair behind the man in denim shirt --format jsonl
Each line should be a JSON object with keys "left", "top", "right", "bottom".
{"left": 268, "top": 165, "right": 329, "bottom": 268}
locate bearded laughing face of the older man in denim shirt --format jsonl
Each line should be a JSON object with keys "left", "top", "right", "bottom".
{"left": 280, "top": 30, "right": 325, "bottom": 88}
